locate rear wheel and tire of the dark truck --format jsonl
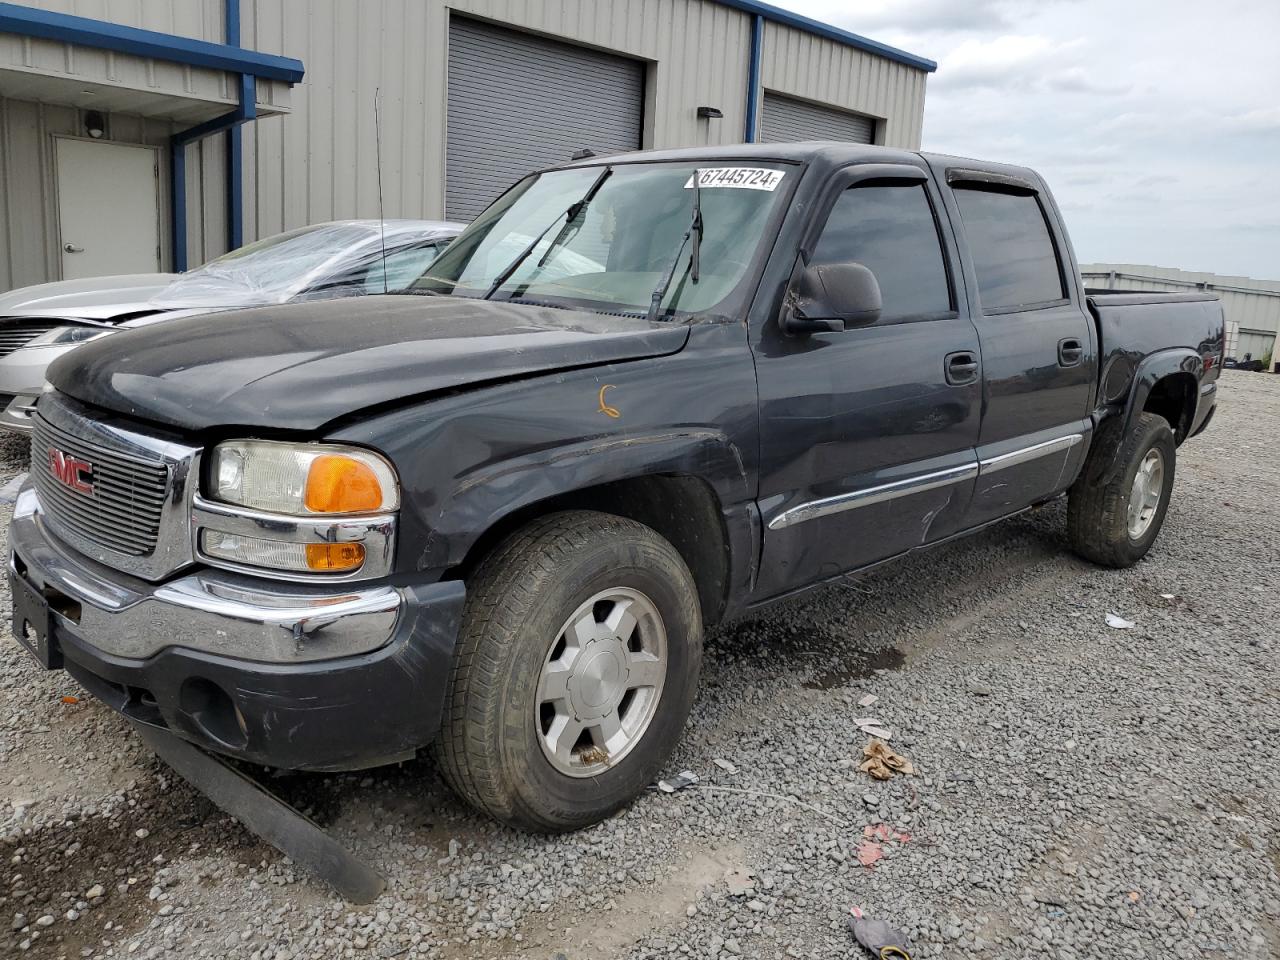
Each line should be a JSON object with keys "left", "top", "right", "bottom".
{"left": 1066, "top": 413, "right": 1176, "bottom": 568}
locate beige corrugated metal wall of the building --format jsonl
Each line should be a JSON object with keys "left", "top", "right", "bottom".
{"left": 0, "top": 0, "right": 927, "bottom": 288}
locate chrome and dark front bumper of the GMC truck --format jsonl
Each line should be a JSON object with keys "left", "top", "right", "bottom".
{"left": 9, "top": 488, "right": 465, "bottom": 771}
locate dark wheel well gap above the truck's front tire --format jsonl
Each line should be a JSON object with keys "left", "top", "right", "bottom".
{"left": 447, "top": 475, "right": 728, "bottom": 626}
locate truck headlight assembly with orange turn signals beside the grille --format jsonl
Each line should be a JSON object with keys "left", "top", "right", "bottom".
{"left": 196, "top": 440, "right": 399, "bottom": 576}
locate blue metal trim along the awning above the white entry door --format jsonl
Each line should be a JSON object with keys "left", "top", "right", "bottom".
{"left": 0, "top": 3, "right": 303, "bottom": 83}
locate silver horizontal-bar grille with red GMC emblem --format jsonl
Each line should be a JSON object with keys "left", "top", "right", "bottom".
{"left": 31, "top": 411, "right": 169, "bottom": 557}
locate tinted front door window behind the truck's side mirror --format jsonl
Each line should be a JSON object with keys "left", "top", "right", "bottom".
{"left": 813, "top": 183, "right": 952, "bottom": 323}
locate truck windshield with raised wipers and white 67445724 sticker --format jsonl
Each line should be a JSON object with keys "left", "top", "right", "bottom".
{"left": 407, "top": 161, "right": 795, "bottom": 317}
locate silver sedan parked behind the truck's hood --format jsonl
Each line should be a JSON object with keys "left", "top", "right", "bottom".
{"left": 0, "top": 220, "right": 463, "bottom": 433}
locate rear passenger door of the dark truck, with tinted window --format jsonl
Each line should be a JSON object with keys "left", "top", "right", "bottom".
{"left": 946, "top": 169, "right": 1097, "bottom": 525}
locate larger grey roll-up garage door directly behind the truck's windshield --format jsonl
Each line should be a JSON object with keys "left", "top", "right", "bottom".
{"left": 444, "top": 17, "right": 644, "bottom": 220}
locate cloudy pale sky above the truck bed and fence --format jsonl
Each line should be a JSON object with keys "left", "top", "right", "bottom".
{"left": 773, "top": 0, "right": 1280, "bottom": 279}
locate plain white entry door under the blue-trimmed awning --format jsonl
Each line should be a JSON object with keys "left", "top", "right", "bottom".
{"left": 54, "top": 137, "right": 160, "bottom": 280}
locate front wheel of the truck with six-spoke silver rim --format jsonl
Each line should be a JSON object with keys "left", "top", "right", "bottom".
{"left": 435, "top": 511, "right": 703, "bottom": 832}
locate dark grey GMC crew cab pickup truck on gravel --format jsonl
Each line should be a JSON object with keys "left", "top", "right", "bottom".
{"left": 10, "top": 143, "right": 1224, "bottom": 831}
